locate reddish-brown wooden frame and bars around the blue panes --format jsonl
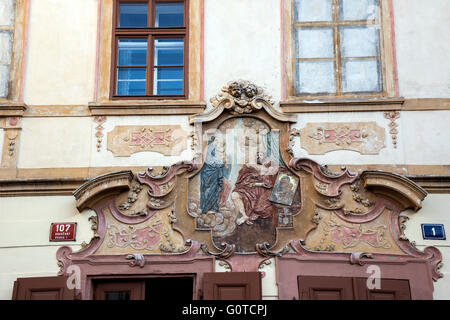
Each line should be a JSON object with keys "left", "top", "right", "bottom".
{"left": 109, "top": 0, "right": 189, "bottom": 100}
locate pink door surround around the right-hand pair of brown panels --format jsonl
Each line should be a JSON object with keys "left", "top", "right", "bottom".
{"left": 275, "top": 244, "right": 442, "bottom": 300}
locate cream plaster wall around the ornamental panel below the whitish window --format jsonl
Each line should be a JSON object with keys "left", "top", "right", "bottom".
{"left": 293, "top": 110, "right": 450, "bottom": 166}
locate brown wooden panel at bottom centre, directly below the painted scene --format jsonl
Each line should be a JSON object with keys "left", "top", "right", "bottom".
{"left": 203, "top": 272, "right": 262, "bottom": 300}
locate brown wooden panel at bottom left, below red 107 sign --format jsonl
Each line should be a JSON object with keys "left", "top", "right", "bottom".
{"left": 12, "top": 276, "right": 74, "bottom": 300}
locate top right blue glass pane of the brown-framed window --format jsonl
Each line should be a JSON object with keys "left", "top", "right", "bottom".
{"left": 155, "top": 2, "right": 184, "bottom": 27}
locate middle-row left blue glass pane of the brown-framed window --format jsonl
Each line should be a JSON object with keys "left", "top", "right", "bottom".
{"left": 118, "top": 39, "right": 147, "bottom": 66}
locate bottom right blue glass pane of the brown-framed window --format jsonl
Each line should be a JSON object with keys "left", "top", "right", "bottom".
{"left": 154, "top": 68, "right": 183, "bottom": 95}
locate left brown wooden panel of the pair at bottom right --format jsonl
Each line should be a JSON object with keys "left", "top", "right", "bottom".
{"left": 298, "top": 276, "right": 355, "bottom": 300}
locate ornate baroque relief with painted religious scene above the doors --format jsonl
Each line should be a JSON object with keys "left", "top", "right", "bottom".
{"left": 57, "top": 81, "right": 442, "bottom": 297}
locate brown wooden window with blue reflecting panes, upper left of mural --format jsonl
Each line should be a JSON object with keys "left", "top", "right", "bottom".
{"left": 111, "top": 0, "right": 188, "bottom": 99}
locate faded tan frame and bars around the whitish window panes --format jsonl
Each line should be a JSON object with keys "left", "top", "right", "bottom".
{"left": 282, "top": 0, "right": 398, "bottom": 101}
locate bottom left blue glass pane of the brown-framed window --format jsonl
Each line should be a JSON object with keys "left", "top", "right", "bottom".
{"left": 117, "top": 68, "right": 146, "bottom": 95}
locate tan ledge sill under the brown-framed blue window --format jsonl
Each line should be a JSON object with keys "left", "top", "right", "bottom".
{"left": 89, "top": 100, "right": 206, "bottom": 116}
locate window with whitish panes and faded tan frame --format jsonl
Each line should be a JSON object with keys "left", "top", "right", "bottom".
{"left": 286, "top": 0, "right": 392, "bottom": 97}
